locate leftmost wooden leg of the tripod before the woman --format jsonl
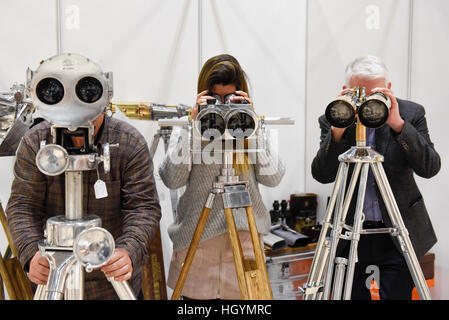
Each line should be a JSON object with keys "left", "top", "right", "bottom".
{"left": 171, "top": 193, "right": 215, "bottom": 300}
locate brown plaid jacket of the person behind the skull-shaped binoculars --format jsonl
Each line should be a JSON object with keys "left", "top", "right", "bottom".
{"left": 6, "top": 117, "right": 161, "bottom": 300}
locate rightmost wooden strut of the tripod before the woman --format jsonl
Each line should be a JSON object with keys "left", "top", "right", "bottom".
{"left": 245, "top": 206, "right": 273, "bottom": 300}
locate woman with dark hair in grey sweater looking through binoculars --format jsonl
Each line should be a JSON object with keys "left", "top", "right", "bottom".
{"left": 159, "top": 54, "right": 285, "bottom": 299}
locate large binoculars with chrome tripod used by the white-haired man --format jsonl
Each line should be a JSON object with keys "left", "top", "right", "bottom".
{"left": 301, "top": 88, "right": 431, "bottom": 300}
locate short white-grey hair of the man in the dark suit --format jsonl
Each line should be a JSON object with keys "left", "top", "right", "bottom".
{"left": 345, "top": 55, "right": 388, "bottom": 87}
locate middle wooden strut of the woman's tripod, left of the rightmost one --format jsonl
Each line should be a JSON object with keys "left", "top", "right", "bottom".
{"left": 224, "top": 208, "right": 249, "bottom": 300}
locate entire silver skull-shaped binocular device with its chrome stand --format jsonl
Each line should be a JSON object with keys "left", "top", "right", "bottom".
{"left": 26, "top": 53, "right": 135, "bottom": 300}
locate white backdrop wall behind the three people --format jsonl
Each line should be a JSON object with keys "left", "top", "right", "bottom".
{"left": 0, "top": 0, "right": 449, "bottom": 299}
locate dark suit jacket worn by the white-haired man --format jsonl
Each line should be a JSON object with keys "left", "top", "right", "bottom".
{"left": 312, "top": 99, "right": 441, "bottom": 258}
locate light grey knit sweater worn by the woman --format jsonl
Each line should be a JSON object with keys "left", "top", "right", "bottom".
{"left": 159, "top": 127, "right": 285, "bottom": 251}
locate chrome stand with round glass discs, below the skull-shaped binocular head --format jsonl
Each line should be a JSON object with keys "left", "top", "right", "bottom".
{"left": 34, "top": 125, "right": 135, "bottom": 300}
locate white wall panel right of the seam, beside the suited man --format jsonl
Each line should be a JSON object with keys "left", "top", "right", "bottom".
{"left": 411, "top": 0, "right": 449, "bottom": 299}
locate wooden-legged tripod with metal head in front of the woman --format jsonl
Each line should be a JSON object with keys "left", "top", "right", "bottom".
{"left": 171, "top": 151, "right": 273, "bottom": 300}
